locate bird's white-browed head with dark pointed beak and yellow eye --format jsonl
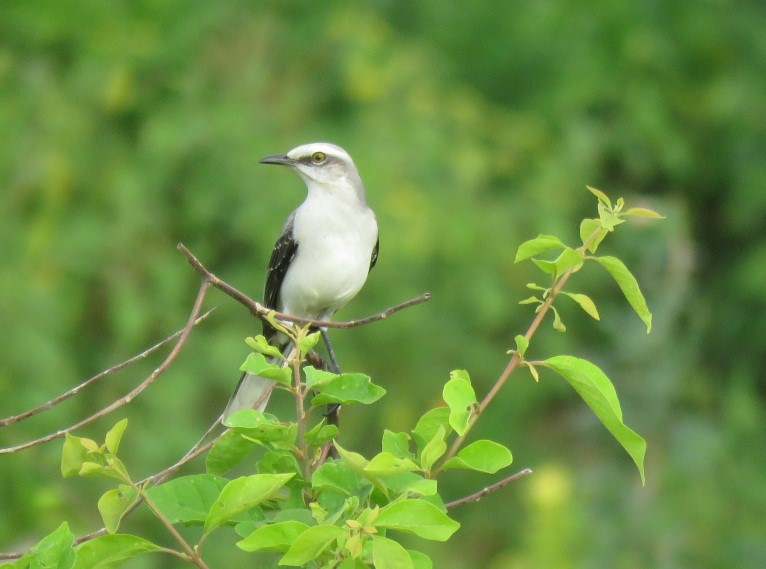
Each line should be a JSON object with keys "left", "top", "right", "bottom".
{"left": 260, "top": 142, "right": 362, "bottom": 194}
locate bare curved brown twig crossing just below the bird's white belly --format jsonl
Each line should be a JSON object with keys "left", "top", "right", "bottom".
{"left": 178, "top": 243, "right": 431, "bottom": 328}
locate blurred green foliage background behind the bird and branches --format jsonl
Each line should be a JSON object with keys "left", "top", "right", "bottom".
{"left": 0, "top": 0, "right": 766, "bottom": 569}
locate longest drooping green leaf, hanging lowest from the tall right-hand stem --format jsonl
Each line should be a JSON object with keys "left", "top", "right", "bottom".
{"left": 540, "top": 356, "right": 646, "bottom": 483}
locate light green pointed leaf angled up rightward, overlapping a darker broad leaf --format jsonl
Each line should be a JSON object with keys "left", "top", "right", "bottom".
{"left": 205, "top": 474, "right": 294, "bottom": 534}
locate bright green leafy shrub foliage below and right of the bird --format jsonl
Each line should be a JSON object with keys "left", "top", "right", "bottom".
{"left": 3, "top": 188, "right": 659, "bottom": 569}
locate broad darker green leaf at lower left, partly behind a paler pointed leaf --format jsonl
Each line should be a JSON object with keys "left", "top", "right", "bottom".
{"left": 147, "top": 474, "right": 229, "bottom": 524}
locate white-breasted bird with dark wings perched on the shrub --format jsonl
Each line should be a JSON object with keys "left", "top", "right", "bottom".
{"left": 222, "top": 142, "right": 380, "bottom": 420}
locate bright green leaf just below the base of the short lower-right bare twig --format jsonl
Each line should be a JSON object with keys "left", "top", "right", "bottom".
{"left": 375, "top": 499, "right": 460, "bottom": 541}
